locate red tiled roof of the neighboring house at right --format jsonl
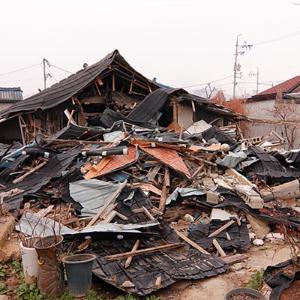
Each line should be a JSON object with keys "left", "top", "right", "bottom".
{"left": 249, "top": 76, "right": 300, "bottom": 101}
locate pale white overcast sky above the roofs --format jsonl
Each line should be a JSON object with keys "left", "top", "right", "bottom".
{"left": 0, "top": 0, "right": 300, "bottom": 97}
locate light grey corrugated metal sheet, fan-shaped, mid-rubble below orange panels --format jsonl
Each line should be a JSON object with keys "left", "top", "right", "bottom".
{"left": 69, "top": 179, "right": 125, "bottom": 217}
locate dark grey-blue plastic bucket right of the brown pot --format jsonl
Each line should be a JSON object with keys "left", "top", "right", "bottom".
{"left": 63, "top": 254, "right": 96, "bottom": 297}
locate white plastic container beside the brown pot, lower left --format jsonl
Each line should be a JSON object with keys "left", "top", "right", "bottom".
{"left": 20, "top": 238, "right": 39, "bottom": 284}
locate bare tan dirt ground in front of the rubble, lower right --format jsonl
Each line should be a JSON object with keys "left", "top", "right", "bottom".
{"left": 156, "top": 243, "right": 291, "bottom": 300}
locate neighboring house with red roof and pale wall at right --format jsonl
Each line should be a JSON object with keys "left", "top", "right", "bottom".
{"left": 246, "top": 76, "right": 300, "bottom": 147}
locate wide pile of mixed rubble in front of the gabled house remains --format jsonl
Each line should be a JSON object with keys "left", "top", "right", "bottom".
{"left": 0, "top": 116, "right": 300, "bottom": 295}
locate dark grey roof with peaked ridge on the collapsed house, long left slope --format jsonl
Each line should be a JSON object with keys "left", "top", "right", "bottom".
{"left": 0, "top": 50, "right": 155, "bottom": 117}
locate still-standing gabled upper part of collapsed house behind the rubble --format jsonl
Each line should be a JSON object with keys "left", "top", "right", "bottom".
{"left": 0, "top": 50, "right": 237, "bottom": 144}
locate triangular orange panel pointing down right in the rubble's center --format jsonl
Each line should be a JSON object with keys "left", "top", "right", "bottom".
{"left": 134, "top": 140, "right": 191, "bottom": 178}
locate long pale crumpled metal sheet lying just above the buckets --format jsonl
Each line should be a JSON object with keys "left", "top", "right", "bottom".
{"left": 16, "top": 212, "right": 159, "bottom": 237}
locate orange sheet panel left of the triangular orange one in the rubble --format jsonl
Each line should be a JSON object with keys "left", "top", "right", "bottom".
{"left": 84, "top": 146, "right": 138, "bottom": 179}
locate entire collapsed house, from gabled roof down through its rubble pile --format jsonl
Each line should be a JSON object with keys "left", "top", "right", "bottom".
{"left": 0, "top": 51, "right": 300, "bottom": 296}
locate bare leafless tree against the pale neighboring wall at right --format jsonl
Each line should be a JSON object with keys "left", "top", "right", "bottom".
{"left": 271, "top": 93, "right": 297, "bottom": 149}
